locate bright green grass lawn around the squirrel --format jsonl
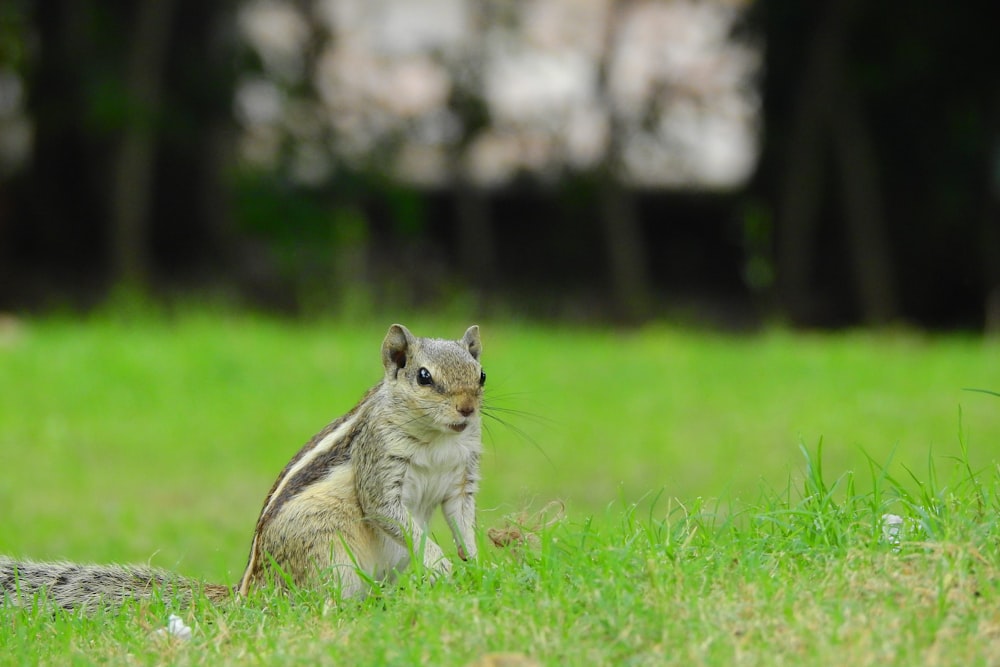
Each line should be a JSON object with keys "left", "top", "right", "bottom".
{"left": 0, "top": 313, "right": 1000, "bottom": 665}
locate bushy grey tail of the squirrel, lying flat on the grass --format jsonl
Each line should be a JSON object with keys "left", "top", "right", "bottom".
{"left": 0, "top": 556, "right": 233, "bottom": 609}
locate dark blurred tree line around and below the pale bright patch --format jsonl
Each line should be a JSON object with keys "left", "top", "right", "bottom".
{"left": 0, "top": 0, "right": 1000, "bottom": 330}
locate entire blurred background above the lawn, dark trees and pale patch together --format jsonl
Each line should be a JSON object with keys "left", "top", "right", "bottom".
{"left": 0, "top": 0, "right": 1000, "bottom": 332}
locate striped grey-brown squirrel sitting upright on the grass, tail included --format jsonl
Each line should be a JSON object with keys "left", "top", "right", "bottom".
{"left": 0, "top": 324, "right": 486, "bottom": 608}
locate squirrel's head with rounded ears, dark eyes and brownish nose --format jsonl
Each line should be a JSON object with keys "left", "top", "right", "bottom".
{"left": 382, "top": 324, "right": 486, "bottom": 433}
